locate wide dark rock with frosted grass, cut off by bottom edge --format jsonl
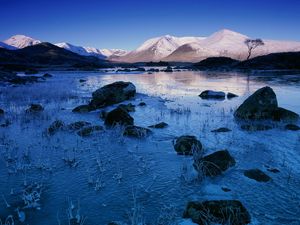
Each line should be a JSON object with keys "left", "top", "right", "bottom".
{"left": 183, "top": 200, "right": 251, "bottom": 225}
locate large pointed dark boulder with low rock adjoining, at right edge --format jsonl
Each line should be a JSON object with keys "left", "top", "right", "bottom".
{"left": 234, "top": 86, "right": 299, "bottom": 121}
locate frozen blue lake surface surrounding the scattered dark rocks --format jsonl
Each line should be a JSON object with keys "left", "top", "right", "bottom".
{"left": 0, "top": 71, "right": 300, "bottom": 225}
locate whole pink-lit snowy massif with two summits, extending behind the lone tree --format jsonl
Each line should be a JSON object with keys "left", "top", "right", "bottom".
{"left": 110, "top": 29, "right": 300, "bottom": 62}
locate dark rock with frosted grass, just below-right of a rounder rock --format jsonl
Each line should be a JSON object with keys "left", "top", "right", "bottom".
{"left": 194, "top": 150, "right": 235, "bottom": 177}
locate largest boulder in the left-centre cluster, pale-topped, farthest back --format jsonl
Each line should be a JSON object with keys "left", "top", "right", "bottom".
{"left": 90, "top": 81, "right": 136, "bottom": 108}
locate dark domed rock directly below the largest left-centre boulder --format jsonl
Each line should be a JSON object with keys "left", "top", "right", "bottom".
{"left": 105, "top": 107, "right": 134, "bottom": 126}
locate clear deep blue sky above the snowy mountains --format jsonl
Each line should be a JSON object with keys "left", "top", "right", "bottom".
{"left": 0, "top": 0, "right": 300, "bottom": 50}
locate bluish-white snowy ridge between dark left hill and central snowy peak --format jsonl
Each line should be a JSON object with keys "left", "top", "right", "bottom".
{"left": 55, "top": 42, "right": 127, "bottom": 59}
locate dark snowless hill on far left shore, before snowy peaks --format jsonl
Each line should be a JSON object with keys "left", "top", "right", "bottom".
{"left": 0, "top": 42, "right": 105, "bottom": 66}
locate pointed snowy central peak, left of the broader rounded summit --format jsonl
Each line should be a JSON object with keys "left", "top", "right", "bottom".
{"left": 109, "top": 35, "right": 203, "bottom": 62}
